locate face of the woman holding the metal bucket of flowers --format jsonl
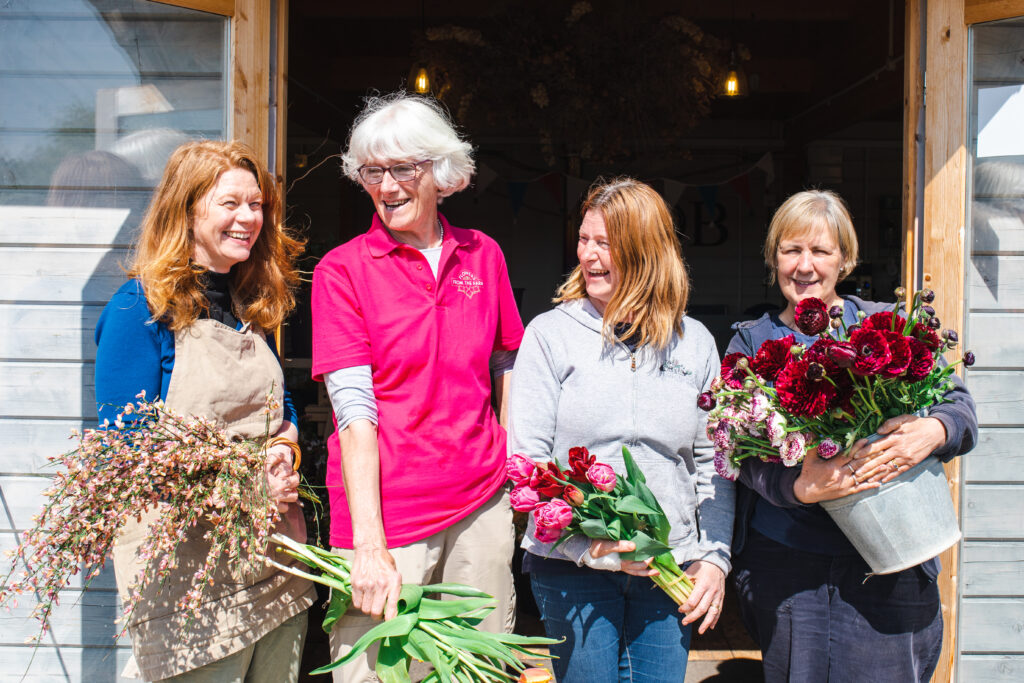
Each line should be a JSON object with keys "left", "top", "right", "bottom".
{"left": 776, "top": 227, "right": 845, "bottom": 310}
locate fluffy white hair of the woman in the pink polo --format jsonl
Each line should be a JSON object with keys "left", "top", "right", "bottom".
{"left": 341, "top": 90, "right": 475, "bottom": 200}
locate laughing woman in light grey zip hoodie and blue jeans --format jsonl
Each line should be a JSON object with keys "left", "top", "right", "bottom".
{"left": 509, "top": 178, "right": 733, "bottom": 683}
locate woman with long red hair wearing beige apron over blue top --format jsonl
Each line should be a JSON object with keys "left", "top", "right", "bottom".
{"left": 95, "top": 141, "right": 315, "bottom": 683}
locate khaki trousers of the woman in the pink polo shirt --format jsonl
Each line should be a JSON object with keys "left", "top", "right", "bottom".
{"left": 331, "top": 487, "right": 515, "bottom": 683}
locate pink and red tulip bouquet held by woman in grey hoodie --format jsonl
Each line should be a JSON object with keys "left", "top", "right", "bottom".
{"left": 507, "top": 446, "right": 693, "bottom": 605}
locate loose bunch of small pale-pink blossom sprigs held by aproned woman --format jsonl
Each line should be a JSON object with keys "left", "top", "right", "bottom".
{"left": 0, "top": 394, "right": 288, "bottom": 640}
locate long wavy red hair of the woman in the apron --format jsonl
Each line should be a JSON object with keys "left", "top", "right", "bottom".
{"left": 128, "top": 140, "right": 303, "bottom": 330}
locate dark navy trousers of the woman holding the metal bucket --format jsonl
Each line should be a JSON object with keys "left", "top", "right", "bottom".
{"left": 733, "top": 529, "right": 942, "bottom": 683}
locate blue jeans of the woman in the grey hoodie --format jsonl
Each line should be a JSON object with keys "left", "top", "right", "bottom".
{"left": 529, "top": 569, "right": 690, "bottom": 683}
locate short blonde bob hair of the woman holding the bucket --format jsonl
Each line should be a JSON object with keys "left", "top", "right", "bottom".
{"left": 764, "top": 189, "right": 858, "bottom": 284}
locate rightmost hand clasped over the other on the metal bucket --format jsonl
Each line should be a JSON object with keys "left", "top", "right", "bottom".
{"left": 853, "top": 415, "right": 946, "bottom": 483}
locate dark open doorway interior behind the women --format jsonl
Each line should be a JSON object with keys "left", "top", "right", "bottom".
{"left": 284, "top": 0, "right": 904, "bottom": 680}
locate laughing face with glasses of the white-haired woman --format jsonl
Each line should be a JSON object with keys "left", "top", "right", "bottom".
{"left": 361, "top": 159, "right": 441, "bottom": 243}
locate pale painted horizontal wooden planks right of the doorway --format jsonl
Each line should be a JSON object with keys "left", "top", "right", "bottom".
{"left": 957, "top": 169, "right": 1024, "bottom": 683}
